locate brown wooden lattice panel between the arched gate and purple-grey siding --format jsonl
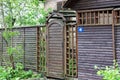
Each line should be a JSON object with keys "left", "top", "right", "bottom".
{"left": 66, "top": 25, "right": 77, "bottom": 77}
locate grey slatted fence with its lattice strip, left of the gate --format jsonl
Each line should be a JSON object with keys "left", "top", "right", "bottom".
{"left": 0, "top": 25, "right": 46, "bottom": 71}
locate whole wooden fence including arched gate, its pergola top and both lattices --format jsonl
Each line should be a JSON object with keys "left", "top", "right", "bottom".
{"left": 0, "top": 11, "right": 78, "bottom": 79}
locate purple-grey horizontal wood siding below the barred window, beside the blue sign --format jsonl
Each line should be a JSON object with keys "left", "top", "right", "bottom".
{"left": 78, "top": 26, "right": 113, "bottom": 80}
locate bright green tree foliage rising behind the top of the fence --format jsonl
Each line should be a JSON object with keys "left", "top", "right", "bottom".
{"left": 0, "top": 0, "right": 51, "bottom": 27}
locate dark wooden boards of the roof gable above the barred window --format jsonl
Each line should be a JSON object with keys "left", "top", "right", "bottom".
{"left": 70, "top": 0, "right": 120, "bottom": 10}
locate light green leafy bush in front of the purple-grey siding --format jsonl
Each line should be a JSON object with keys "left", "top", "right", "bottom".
{"left": 95, "top": 64, "right": 120, "bottom": 80}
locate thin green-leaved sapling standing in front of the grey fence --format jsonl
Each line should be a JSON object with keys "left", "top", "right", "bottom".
{"left": 2, "top": 28, "right": 23, "bottom": 68}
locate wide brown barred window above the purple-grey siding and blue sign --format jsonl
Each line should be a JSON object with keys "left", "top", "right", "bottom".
{"left": 78, "top": 10, "right": 112, "bottom": 25}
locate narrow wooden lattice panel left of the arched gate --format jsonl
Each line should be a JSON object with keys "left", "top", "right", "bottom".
{"left": 39, "top": 27, "right": 46, "bottom": 72}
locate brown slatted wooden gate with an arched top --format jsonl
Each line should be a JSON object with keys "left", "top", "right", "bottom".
{"left": 47, "top": 14, "right": 65, "bottom": 78}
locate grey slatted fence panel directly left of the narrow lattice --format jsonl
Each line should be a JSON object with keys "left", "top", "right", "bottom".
{"left": 24, "top": 28, "right": 37, "bottom": 70}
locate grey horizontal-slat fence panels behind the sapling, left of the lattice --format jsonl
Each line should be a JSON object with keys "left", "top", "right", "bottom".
{"left": 0, "top": 25, "right": 46, "bottom": 71}
